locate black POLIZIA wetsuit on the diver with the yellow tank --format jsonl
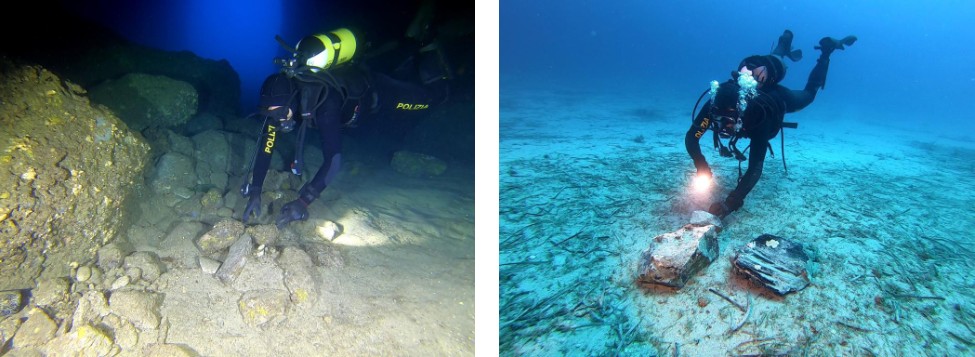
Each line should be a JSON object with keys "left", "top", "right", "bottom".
{"left": 251, "top": 65, "right": 447, "bottom": 205}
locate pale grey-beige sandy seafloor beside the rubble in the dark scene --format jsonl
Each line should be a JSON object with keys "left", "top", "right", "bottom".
{"left": 129, "top": 146, "right": 474, "bottom": 356}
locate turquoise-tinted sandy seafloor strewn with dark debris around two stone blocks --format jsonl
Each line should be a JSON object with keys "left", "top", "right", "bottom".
{"left": 499, "top": 81, "right": 975, "bottom": 356}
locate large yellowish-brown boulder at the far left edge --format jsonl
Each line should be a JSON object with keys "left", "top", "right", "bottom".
{"left": 0, "top": 57, "right": 149, "bottom": 290}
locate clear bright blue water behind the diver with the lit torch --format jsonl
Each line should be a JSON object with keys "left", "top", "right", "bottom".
{"left": 500, "top": 0, "right": 975, "bottom": 132}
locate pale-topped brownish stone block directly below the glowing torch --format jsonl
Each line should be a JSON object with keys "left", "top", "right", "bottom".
{"left": 637, "top": 224, "right": 718, "bottom": 289}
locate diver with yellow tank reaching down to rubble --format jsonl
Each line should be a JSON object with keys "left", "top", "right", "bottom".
{"left": 241, "top": 29, "right": 450, "bottom": 228}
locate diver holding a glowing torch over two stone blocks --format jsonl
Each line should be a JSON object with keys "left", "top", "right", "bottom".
{"left": 684, "top": 30, "right": 856, "bottom": 218}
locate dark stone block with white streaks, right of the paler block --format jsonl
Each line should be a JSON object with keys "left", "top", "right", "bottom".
{"left": 731, "top": 234, "right": 809, "bottom": 296}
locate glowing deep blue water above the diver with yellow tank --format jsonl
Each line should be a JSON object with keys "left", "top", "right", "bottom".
{"left": 62, "top": 0, "right": 450, "bottom": 112}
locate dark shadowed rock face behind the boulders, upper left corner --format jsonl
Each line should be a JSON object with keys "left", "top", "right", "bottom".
{"left": 0, "top": 4, "right": 240, "bottom": 117}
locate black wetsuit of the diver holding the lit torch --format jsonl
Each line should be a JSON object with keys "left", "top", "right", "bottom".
{"left": 684, "top": 55, "right": 829, "bottom": 216}
